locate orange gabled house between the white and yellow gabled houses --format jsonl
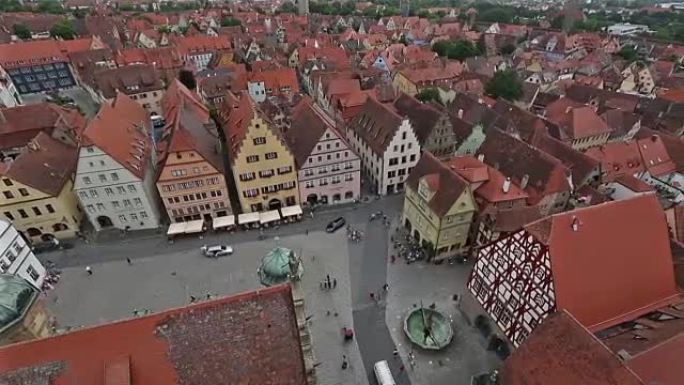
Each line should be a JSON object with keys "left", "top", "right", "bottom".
{"left": 156, "top": 80, "right": 232, "bottom": 223}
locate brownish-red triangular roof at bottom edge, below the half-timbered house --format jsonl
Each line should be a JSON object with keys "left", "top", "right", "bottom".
{"left": 500, "top": 310, "right": 644, "bottom": 385}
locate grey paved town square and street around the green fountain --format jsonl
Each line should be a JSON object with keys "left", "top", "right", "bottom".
{"left": 39, "top": 196, "right": 498, "bottom": 385}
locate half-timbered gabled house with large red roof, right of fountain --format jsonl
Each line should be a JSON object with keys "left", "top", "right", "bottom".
{"left": 467, "top": 194, "right": 678, "bottom": 347}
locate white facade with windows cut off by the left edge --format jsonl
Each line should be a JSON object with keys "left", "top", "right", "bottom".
{"left": 0, "top": 219, "right": 47, "bottom": 290}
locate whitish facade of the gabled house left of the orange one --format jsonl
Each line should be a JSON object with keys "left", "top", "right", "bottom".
{"left": 74, "top": 145, "right": 159, "bottom": 231}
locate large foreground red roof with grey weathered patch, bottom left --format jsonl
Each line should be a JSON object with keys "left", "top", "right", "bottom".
{"left": 0, "top": 285, "right": 306, "bottom": 385}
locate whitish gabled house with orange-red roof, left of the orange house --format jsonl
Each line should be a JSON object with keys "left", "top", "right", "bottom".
{"left": 74, "top": 93, "right": 160, "bottom": 231}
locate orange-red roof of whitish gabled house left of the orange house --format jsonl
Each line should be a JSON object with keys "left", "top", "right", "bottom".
{"left": 83, "top": 92, "right": 152, "bottom": 180}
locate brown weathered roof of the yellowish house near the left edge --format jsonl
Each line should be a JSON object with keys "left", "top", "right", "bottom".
{"left": 0, "top": 132, "right": 78, "bottom": 196}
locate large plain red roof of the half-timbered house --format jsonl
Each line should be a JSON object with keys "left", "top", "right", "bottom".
{"left": 525, "top": 194, "right": 678, "bottom": 331}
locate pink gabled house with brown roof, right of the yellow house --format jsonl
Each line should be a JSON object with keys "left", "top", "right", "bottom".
{"left": 283, "top": 98, "right": 361, "bottom": 206}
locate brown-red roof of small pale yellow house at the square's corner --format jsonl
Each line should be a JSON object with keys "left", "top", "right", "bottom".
{"left": 406, "top": 151, "right": 468, "bottom": 217}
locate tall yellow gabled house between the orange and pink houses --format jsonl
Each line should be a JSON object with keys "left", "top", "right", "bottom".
{"left": 224, "top": 94, "right": 299, "bottom": 213}
